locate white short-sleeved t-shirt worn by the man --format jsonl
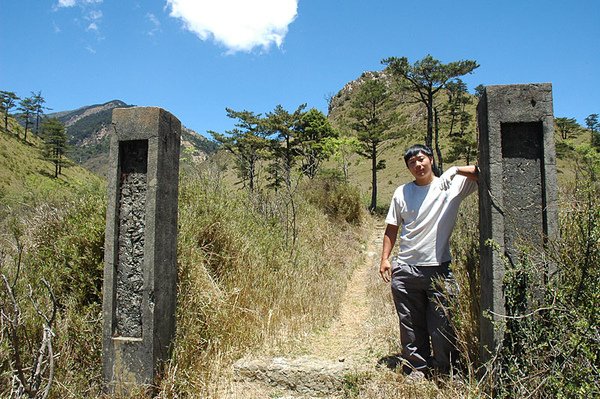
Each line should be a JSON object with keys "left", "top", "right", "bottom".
{"left": 385, "top": 175, "right": 477, "bottom": 266}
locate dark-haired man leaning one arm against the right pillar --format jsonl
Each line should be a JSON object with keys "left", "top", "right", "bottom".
{"left": 379, "top": 144, "right": 477, "bottom": 377}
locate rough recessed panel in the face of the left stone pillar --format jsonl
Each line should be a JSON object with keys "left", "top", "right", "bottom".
{"left": 115, "top": 140, "right": 148, "bottom": 338}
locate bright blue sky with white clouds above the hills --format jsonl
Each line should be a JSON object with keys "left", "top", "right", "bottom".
{"left": 0, "top": 0, "right": 600, "bottom": 134}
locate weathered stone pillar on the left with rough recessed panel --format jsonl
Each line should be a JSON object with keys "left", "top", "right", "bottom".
{"left": 102, "top": 107, "right": 181, "bottom": 394}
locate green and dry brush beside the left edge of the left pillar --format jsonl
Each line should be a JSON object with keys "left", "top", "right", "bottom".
{"left": 0, "top": 186, "right": 104, "bottom": 397}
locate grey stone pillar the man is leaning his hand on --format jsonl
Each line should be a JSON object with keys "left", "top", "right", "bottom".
{"left": 477, "top": 83, "right": 558, "bottom": 361}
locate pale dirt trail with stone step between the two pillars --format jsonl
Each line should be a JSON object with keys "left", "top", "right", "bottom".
{"left": 229, "top": 224, "right": 390, "bottom": 399}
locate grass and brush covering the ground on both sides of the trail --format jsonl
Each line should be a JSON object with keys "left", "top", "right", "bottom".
{"left": 0, "top": 117, "right": 600, "bottom": 399}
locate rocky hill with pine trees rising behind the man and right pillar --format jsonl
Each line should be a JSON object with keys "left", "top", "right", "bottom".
{"left": 328, "top": 61, "right": 600, "bottom": 208}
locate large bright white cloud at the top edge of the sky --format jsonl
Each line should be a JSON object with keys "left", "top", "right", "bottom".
{"left": 167, "top": 0, "right": 298, "bottom": 53}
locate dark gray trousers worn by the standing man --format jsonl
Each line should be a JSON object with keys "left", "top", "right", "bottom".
{"left": 391, "top": 262, "right": 458, "bottom": 373}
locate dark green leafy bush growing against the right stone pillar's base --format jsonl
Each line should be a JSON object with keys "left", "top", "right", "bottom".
{"left": 493, "top": 154, "right": 600, "bottom": 398}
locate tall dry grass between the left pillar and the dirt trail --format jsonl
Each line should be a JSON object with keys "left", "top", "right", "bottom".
{"left": 157, "top": 169, "right": 364, "bottom": 397}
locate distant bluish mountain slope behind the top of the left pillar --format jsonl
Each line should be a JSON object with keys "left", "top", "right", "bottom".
{"left": 47, "top": 100, "right": 216, "bottom": 176}
